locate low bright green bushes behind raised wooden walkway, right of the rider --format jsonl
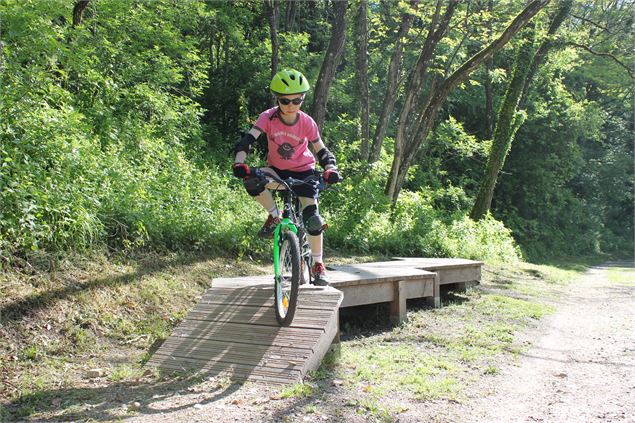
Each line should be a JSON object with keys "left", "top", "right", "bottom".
{"left": 322, "top": 149, "right": 519, "bottom": 261}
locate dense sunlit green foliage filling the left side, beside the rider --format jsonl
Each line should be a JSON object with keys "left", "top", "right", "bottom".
{"left": 0, "top": 2, "right": 262, "bottom": 262}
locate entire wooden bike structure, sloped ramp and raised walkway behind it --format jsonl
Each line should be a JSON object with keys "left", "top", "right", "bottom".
{"left": 148, "top": 257, "right": 483, "bottom": 384}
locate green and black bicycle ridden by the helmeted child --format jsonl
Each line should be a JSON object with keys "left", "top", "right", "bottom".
{"left": 256, "top": 169, "right": 326, "bottom": 326}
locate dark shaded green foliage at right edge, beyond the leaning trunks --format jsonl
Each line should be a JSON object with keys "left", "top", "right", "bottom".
{"left": 494, "top": 37, "right": 633, "bottom": 258}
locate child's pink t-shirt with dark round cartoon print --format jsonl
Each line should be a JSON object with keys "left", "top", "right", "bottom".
{"left": 255, "top": 107, "right": 320, "bottom": 172}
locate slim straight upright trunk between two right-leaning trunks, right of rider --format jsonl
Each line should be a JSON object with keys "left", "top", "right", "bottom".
{"left": 357, "top": 0, "right": 370, "bottom": 161}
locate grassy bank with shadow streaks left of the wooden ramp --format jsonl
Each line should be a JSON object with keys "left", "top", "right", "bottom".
{"left": 0, "top": 248, "right": 270, "bottom": 419}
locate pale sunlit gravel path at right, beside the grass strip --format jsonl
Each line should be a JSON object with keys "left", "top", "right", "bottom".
{"left": 451, "top": 263, "right": 635, "bottom": 422}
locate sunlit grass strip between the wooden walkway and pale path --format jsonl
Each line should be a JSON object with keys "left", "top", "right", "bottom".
{"left": 280, "top": 263, "right": 586, "bottom": 421}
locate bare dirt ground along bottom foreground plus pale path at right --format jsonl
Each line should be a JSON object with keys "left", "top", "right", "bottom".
{"left": 126, "top": 263, "right": 635, "bottom": 423}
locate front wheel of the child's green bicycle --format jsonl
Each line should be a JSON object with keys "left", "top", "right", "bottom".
{"left": 274, "top": 231, "right": 301, "bottom": 326}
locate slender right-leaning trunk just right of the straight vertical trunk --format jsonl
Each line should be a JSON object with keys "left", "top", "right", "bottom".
{"left": 368, "top": 0, "right": 417, "bottom": 163}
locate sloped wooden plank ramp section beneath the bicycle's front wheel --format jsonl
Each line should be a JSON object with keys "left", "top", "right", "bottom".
{"left": 147, "top": 286, "right": 343, "bottom": 384}
